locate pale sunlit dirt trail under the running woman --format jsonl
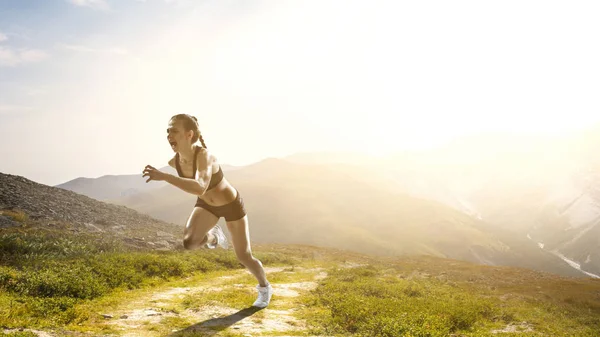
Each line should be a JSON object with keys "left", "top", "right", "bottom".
{"left": 98, "top": 267, "right": 327, "bottom": 337}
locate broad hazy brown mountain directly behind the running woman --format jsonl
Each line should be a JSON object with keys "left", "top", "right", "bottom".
{"left": 106, "top": 158, "right": 582, "bottom": 276}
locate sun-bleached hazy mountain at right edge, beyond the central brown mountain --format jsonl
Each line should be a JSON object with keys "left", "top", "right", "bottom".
{"left": 381, "top": 129, "right": 600, "bottom": 276}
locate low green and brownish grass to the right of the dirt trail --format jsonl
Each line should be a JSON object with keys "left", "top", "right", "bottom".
{"left": 303, "top": 258, "right": 600, "bottom": 336}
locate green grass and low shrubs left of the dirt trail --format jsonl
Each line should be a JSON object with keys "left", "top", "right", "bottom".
{"left": 0, "top": 228, "right": 295, "bottom": 328}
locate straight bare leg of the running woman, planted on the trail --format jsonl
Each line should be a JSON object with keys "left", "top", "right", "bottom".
{"left": 227, "top": 215, "right": 269, "bottom": 287}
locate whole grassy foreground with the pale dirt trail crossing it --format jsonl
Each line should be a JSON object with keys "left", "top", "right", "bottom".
{"left": 0, "top": 215, "right": 600, "bottom": 337}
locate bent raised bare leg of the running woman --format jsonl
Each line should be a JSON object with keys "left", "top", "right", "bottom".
{"left": 183, "top": 206, "right": 219, "bottom": 249}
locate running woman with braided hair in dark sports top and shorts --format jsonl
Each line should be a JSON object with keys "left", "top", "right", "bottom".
{"left": 142, "top": 114, "right": 273, "bottom": 308}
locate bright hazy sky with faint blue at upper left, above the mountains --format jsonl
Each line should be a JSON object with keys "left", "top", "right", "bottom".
{"left": 0, "top": 0, "right": 600, "bottom": 185}
